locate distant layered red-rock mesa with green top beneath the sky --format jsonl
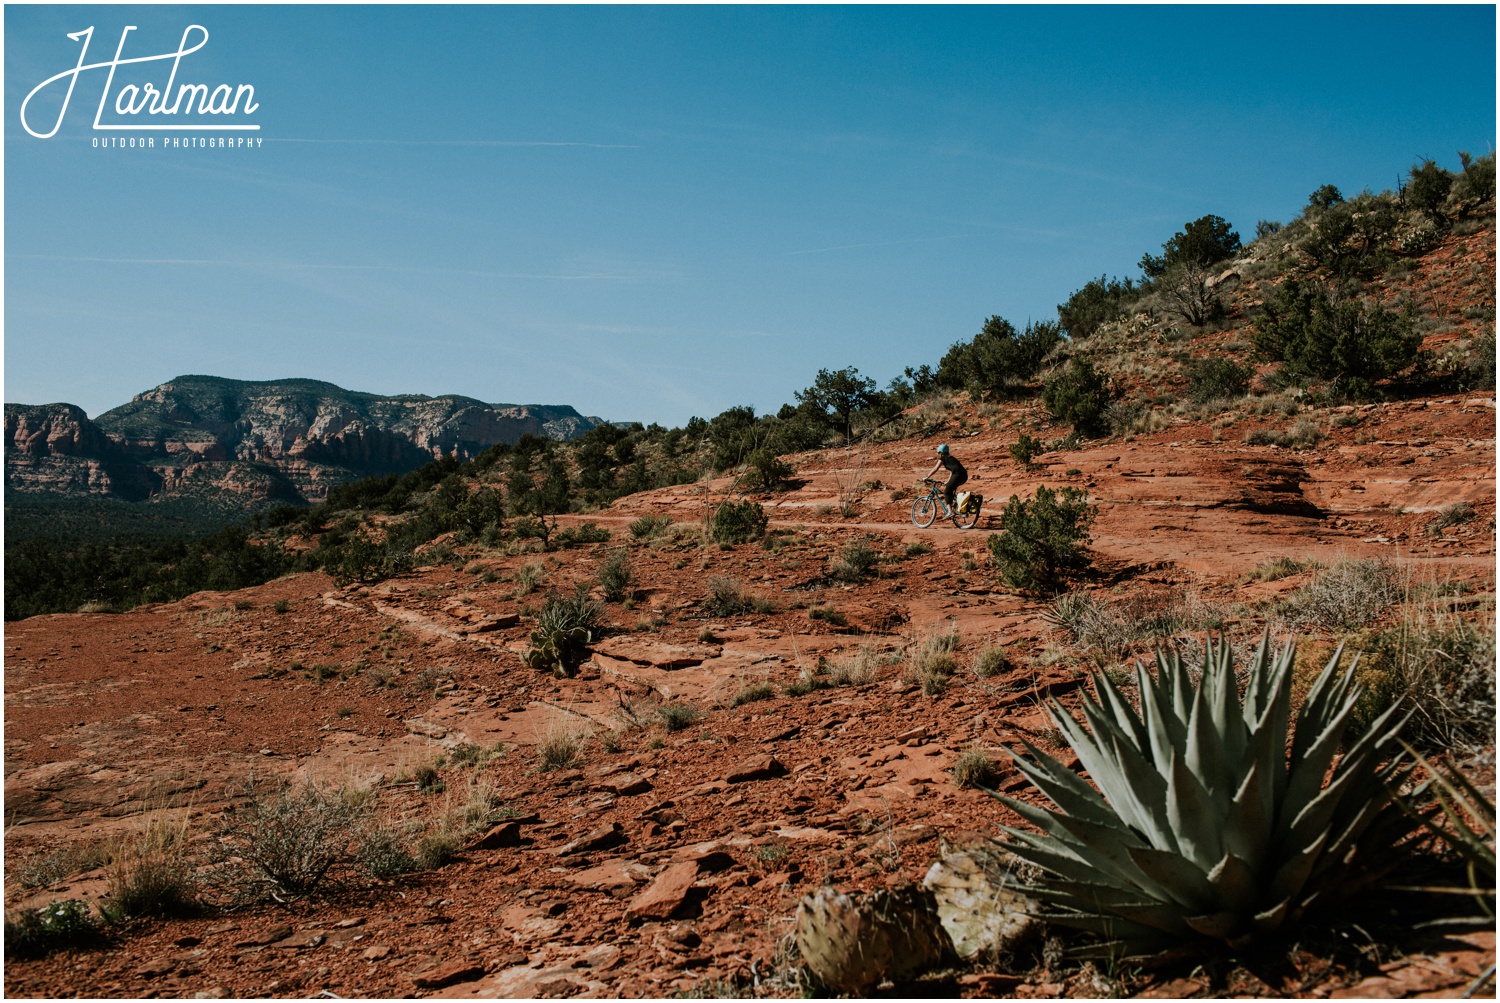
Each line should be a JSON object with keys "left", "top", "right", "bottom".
{"left": 5, "top": 376, "right": 600, "bottom": 508}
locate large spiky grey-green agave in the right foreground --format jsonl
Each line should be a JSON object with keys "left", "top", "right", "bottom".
{"left": 996, "top": 634, "right": 1415, "bottom": 954}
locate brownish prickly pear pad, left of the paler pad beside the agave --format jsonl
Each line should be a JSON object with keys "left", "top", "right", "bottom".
{"left": 797, "top": 886, "right": 950, "bottom": 993}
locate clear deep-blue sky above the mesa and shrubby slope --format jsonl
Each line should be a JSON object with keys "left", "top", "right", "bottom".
{"left": 5, "top": 6, "right": 1496, "bottom": 424}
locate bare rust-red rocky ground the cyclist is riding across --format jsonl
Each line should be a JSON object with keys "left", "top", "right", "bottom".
{"left": 5, "top": 380, "right": 1496, "bottom": 997}
